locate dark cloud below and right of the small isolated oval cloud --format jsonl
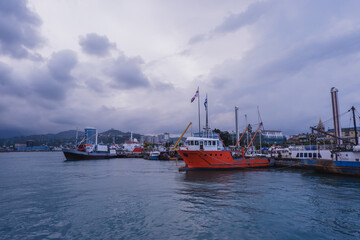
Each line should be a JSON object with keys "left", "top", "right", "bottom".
{"left": 106, "top": 56, "right": 150, "bottom": 89}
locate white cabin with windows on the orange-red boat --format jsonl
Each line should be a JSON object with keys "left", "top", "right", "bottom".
{"left": 186, "top": 137, "right": 223, "bottom": 151}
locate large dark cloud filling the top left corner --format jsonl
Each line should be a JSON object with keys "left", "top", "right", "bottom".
{"left": 0, "top": 0, "right": 43, "bottom": 58}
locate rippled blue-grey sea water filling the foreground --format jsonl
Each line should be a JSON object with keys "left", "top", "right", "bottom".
{"left": 0, "top": 153, "right": 360, "bottom": 239}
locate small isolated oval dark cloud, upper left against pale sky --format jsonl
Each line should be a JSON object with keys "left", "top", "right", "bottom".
{"left": 79, "top": 33, "right": 116, "bottom": 57}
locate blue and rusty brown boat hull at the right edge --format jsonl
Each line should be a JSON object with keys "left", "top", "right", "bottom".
{"left": 301, "top": 159, "right": 360, "bottom": 177}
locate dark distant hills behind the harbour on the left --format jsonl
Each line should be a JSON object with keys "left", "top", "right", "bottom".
{"left": 0, "top": 129, "right": 141, "bottom": 146}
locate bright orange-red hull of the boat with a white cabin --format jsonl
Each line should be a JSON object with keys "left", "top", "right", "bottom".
{"left": 178, "top": 150, "right": 270, "bottom": 170}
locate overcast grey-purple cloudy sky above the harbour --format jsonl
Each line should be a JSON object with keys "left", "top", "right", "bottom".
{"left": 0, "top": 0, "right": 360, "bottom": 134}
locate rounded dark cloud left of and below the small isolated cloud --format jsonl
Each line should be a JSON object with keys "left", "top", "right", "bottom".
{"left": 48, "top": 50, "right": 77, "bottom": 82}
